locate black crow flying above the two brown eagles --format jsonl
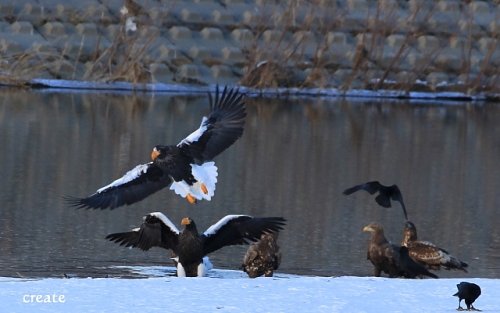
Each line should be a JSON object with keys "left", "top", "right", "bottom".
{"left": 343, "top": 181, "right": 408, "bottom": 220}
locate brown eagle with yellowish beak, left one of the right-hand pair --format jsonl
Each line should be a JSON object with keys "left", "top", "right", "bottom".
{"left": 363, "top": 223, "right": 437, "bottom": 278}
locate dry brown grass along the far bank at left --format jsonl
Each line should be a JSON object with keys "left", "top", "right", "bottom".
{"left": 0, "top": 13, "right": 158, "bottom": 86}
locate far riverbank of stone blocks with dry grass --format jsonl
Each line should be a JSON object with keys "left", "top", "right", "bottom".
{"left": 0, "top": 0, "right": 500, "bottom": 98}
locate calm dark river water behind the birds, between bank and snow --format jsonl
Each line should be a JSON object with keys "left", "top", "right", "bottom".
{"left": 0, "top": 90, "right": 500, "bottom": 278}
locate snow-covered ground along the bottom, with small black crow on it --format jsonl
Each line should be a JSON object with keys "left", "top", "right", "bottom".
{"left": 0, "top": 268, "right": 500, "bottom": 313}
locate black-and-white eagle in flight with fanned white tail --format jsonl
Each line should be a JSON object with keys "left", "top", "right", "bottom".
{"left": 67, "top": 87, "right": 246, "bottom": 209}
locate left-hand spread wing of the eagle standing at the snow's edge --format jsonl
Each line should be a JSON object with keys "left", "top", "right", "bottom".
{"left": 106, "top": 212, "right": 179, "bottom": 251}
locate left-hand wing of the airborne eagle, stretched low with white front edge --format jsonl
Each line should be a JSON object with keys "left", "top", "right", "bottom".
{"left": 66, "top": 162, "right": 172, "bottom": 209}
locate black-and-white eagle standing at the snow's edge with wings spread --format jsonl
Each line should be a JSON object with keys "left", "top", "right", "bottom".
{"left": 106, "top": 212, "right": 286, "bottom": 277}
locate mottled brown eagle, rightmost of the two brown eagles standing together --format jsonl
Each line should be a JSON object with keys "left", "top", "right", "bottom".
{"left": 401, "top": 221, "right": 468, "bottom": 272}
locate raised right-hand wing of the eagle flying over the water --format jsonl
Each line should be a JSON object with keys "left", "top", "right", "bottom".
{"left": 178, "top": 86, "right": 246, "bottom": 163}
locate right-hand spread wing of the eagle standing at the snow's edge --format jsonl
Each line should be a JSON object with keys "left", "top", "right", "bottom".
{"left": 202, "top": 215, "right": 286, "bottom": 255}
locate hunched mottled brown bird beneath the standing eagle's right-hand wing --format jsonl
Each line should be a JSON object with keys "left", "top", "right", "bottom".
{"left": 242, "top": 233, "right": 281, "bottom": 278}
